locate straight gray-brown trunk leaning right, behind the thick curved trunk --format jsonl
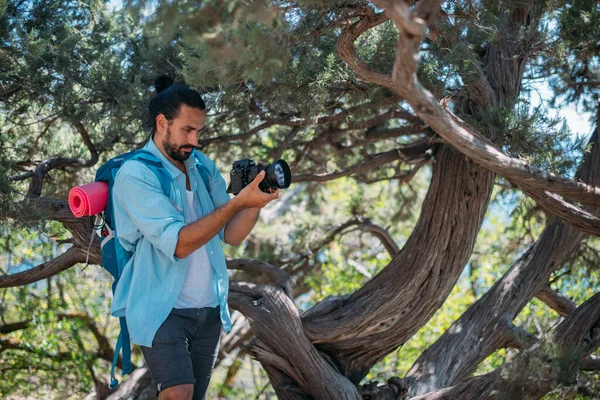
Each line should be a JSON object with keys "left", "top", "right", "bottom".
{"left": 406, "top": 115, "right": 600, "bottom": 396}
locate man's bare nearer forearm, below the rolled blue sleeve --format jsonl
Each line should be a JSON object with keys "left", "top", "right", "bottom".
{"left": 175, "top": 199, "right": 245, "bottom": 258}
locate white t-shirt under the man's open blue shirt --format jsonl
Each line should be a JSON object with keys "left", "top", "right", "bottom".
{"left": 174, "top": 190, "right": 219, "bottom": 308}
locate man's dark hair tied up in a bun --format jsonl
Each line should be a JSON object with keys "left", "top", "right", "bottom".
{"left": 148, "top": 75, "right": 206, "bottom": 137}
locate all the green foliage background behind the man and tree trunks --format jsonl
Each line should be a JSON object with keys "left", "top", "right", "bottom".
{"left": 0, "top": 0, "right": 600, "bottom": 398}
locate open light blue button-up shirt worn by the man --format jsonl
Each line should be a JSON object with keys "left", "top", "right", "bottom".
{"left": 111, "top": 140, "right": 231, "bottom": 347}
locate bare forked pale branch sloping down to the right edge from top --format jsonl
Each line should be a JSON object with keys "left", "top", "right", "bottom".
{"left": 338, "top": 0, "right": 600, "bottom": 227}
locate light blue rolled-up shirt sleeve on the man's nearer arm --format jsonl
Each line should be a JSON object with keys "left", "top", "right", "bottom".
{"left": 113, "top": 160, "right": 185, "bottom": 262}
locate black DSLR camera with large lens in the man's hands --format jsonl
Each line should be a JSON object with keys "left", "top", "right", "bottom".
{"left": 227, "top": 159, "right": 292, "bottom": 195}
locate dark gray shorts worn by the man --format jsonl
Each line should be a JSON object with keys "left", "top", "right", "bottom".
{"left": 140, "top": 307, "right": 221, "bottom": 400}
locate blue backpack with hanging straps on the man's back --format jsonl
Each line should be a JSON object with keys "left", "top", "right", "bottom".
{"left": 94, "top": 149, "right": 209, "bottom": 389}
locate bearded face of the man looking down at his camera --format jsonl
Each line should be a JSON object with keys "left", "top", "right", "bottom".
{"left": 162, "top": 105, "right": 206, "bottom": 162}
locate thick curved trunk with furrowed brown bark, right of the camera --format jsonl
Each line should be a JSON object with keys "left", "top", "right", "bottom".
{"left": 303, "top": 146, "right": 494, "bottom": 383}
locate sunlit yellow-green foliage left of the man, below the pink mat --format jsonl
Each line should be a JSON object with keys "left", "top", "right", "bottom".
{"left": 0, "top": 222, "right": 124, "bottom": 398}
